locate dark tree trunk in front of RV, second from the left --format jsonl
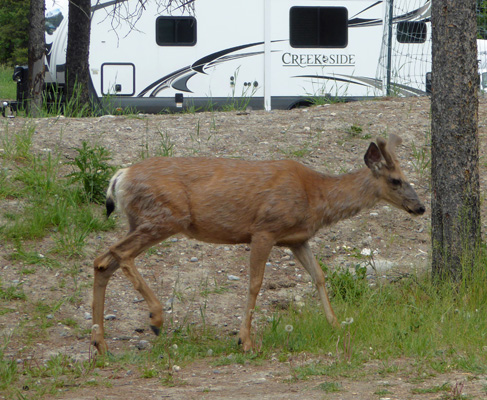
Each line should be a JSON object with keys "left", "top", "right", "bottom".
{"left": 66, "top": 0, "right": 91, "bottom": 110}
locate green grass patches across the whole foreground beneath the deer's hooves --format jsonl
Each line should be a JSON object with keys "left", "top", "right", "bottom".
{"left": 0, "top": 244, "right": 487, "bottom": 399}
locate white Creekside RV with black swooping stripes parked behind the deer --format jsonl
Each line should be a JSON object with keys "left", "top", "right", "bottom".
{"left": 41, "top": 0, "right": 438, "bottom": 112}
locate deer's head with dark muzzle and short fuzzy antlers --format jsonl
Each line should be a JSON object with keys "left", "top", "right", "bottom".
{"left": 364, "top": 134, "right": 425, "bottom": 215}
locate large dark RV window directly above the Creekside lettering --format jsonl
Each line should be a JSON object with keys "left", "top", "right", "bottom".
{"left": 289, "top": 7, "right": 348, "bottom": 47}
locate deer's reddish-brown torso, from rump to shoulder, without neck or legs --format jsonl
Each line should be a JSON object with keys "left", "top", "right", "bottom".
{"left": 117, "top": 158, "right": 321, "bottom": 243}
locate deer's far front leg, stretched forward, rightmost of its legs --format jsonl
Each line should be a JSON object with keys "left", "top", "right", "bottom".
{"left": 291, "top": 242, "right": 339, "bottom": 328}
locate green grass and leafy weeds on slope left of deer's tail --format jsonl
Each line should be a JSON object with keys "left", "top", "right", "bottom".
{"left": 0, "top": 123, "right": 113, "bottom": 257}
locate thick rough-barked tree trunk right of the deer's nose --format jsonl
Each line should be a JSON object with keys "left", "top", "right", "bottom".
{"left": 431, "top": 0, "right": 480, "bottom": 280}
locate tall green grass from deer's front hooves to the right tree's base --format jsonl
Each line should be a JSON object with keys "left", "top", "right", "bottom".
{"left": 255, "top": 260, "right": 487, "bottom": 373}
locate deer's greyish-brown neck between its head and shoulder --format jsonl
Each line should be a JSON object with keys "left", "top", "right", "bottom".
{"left": 315, "top": 168, "right": 380, "bottom": 227}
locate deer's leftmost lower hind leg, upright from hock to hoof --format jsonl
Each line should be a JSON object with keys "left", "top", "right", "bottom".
{"left": 91, "top": 251, "right": 120, "bottom": 354}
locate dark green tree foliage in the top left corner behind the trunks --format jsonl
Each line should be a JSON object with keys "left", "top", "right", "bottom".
{"left": 0, "top": 0, "right": 30, "bottom": 66}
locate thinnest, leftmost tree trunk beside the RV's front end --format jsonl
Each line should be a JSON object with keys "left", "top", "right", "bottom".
{"left": 27, "top": 0, "right": 46, "bottom": 116}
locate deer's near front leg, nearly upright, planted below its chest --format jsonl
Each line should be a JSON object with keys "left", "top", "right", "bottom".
{"left": 238, "top": 234, "right": 274, "bottom": 351}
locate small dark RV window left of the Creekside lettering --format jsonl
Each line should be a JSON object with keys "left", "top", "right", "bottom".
{"left": 156, "top": 17, "right": 196, "bottom": 46}
